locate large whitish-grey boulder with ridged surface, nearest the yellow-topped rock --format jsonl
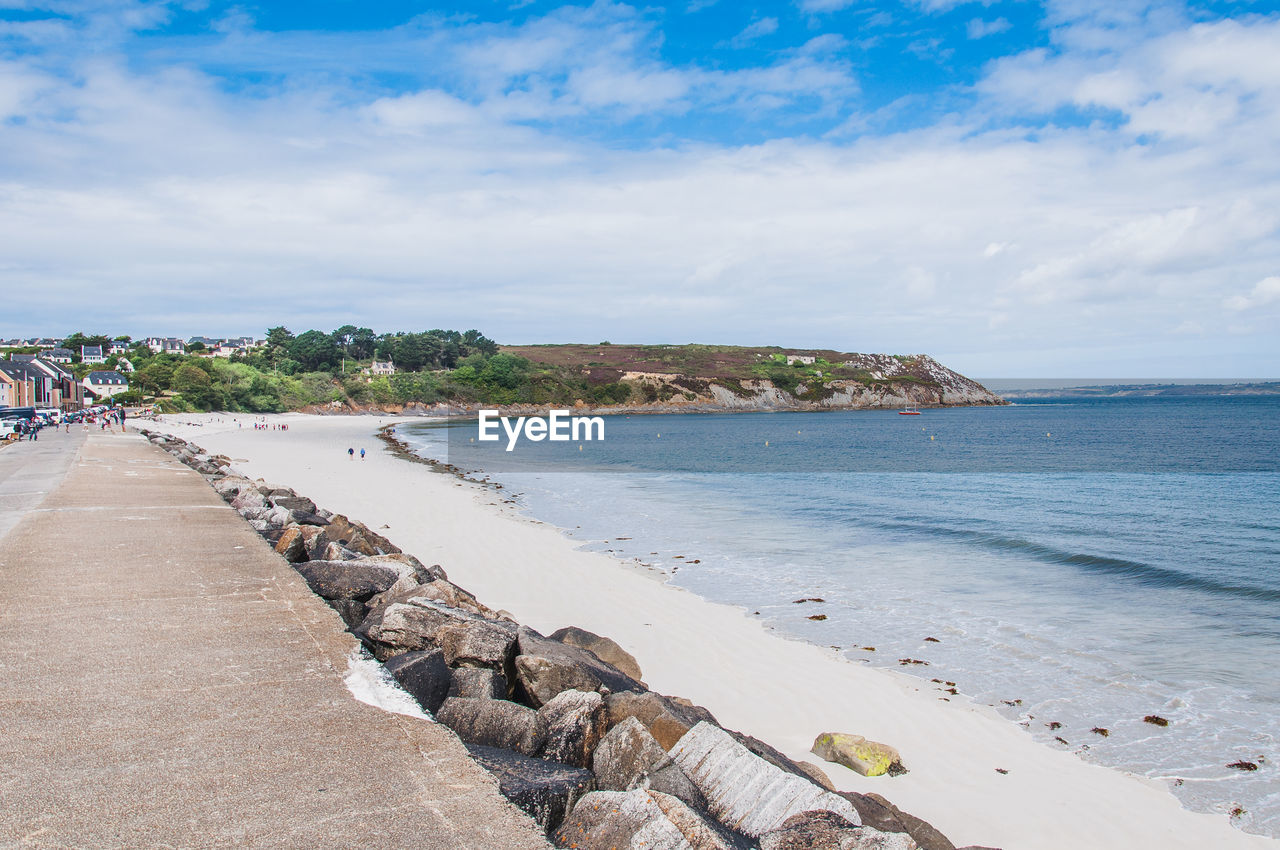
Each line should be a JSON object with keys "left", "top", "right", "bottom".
{"left": 671, "top": 722, "right": 861, "bottom": 837}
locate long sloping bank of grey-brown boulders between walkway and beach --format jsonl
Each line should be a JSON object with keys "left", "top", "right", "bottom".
{"left": 141, "top": 430, "right": 988, "bottom": 850}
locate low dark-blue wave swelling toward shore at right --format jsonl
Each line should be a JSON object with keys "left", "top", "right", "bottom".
{"left": 873, "top": 522, "right": 1280, "bottom": 602}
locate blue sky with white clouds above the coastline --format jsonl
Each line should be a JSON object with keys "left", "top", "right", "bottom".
{"left": 0, "top": 0, "right": 1280, "bottom": 379}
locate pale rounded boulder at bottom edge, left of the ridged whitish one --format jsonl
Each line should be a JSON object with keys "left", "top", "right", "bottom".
{"left": 552, "top": 789, "right": 731, "bottom": 850}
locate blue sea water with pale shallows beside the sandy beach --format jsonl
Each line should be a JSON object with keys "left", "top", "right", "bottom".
{"left": 398, "top": 397, "right": 1280, "bottom": 836}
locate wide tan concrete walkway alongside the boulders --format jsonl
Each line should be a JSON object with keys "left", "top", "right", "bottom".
{"left": 0, "top": 429, "right": 548, "bottom": 850}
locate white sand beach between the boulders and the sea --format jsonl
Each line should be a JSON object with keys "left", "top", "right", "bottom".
{"left": 145, "top": 413, "right": 1280, "bottom": 850}
